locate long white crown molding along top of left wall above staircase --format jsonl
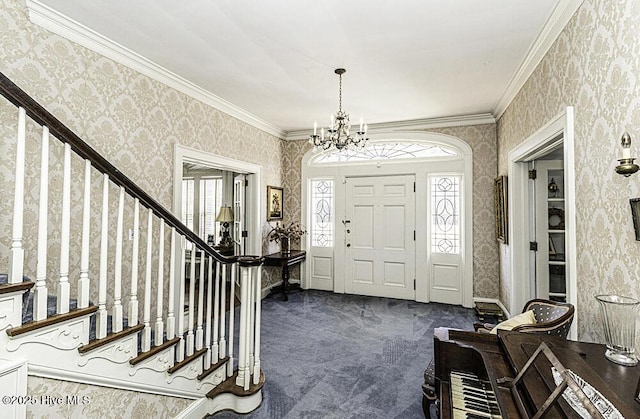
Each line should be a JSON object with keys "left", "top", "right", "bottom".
{"left": 26, "top": 0, "right": 287, "bottom": 138}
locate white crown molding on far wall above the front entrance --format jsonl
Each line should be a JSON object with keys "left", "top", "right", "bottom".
{"left": 285, "top": 113, "right": 496, "bottom": 141}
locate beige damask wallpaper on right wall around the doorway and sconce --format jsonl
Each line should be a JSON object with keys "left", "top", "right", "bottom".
{"left": 498, "top": 0, "right": 640, "bottom": 342}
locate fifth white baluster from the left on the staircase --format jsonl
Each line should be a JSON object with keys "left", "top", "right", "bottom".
{"left": 96, "top": 174, "right": 109, "bottom": 339}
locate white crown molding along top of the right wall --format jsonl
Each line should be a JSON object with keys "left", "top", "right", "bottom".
{"left": 492, "top": 0, "right": 584, "bottom": 119}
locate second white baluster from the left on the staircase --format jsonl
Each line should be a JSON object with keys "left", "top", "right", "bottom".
{"left": 33, "top": 127, "right": 49, "bottom": 320}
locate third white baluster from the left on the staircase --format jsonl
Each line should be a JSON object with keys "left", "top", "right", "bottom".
{"left": 57, "top": 143, "right": 71, "bottom": 314}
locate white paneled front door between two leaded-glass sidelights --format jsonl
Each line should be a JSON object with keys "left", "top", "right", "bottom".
{"left": 344, "top": 175, "right": 416, "bottom": 300}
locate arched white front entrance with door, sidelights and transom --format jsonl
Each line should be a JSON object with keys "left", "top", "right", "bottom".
{"left": 301, "top": 132, "right": 473, "bottom": 307}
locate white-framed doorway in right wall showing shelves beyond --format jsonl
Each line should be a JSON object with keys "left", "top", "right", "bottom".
{"left": 508, "top": 107, "right": 578, "bottom": 338}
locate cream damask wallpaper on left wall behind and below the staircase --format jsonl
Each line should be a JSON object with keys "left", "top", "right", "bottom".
{"left": 0, "top": 0, "right": 282, "bottom": 417}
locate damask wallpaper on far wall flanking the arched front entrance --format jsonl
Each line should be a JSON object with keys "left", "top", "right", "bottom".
{"left": 282, "top": 124, "right": 499, "bottom": 298}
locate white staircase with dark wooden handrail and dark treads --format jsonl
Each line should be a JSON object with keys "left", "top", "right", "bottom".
{"left": 0, "top": 73, "right": 264, "bottom": 418}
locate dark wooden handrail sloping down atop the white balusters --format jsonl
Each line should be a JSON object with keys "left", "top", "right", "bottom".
{"left": 0, "top": 72, "right": 236, "bottom": 263}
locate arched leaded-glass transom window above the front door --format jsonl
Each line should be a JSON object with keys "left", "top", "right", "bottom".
{"left": 310, "top": 141, "right": 459, "bottom": 164}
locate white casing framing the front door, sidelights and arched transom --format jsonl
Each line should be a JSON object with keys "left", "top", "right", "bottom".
{"left": 300, "top": 131, "right": 473, "bottom": 307}
